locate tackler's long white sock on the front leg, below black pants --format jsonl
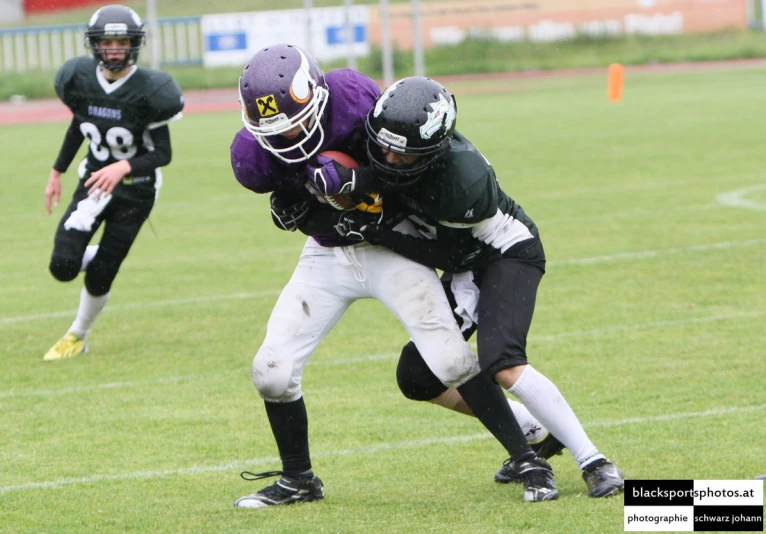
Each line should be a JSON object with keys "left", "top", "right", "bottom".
{"left": 508, "top": 365, "right": 604, "bottom": 469}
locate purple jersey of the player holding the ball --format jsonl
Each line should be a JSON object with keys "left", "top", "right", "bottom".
{"left": 231, "top": 69, "right": 380, "bottom": 246}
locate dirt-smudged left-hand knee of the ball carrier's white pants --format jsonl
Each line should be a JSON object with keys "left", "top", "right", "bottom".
{"left": 250, "top": 346, "right": 301, "bottom": 402}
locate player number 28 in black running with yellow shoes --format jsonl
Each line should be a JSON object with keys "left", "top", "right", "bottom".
{"left": 43, "top": 5, "right": 183, "bottom": 361}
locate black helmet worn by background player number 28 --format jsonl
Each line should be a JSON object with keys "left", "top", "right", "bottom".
{"left": 85, "top": 4, "right": 146, "bottom": 72}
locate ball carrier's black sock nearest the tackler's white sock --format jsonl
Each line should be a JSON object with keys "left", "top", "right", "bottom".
{"left": 457, "top": 373, "right": 535, "bottom": 461}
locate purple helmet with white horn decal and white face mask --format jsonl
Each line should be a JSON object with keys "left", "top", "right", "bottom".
{"left": 239, "top": 44, "right": 329, "bottom": 163}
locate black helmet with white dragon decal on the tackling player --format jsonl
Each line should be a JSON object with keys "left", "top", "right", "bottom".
{"left": 366, "top": 76, "right": 457, "bottom": 185}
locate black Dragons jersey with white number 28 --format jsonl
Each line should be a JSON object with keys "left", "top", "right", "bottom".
{"left": 55, "top": 57, "right": 183, "bottom": 180}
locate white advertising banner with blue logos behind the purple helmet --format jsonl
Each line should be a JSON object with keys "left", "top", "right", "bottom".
{"left": 201, "top": 6, "right": 370, "bottom": 67}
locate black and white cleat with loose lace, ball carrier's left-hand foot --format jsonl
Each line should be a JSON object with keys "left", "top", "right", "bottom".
{"left": 234, "top": 471, "right": 324, "bottom": 508}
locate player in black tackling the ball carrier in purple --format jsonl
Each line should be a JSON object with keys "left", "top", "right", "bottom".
{"left": 310, "top": 77, "right": 623, "bottom": 497}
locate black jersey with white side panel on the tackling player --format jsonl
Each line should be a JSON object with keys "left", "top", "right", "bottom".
{"left": 386, "top": 131, "right": 538, "bottom": 270}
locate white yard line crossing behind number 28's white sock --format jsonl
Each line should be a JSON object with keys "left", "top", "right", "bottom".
{"left": 0, "top": 238, "right": 766, "bottom": 327}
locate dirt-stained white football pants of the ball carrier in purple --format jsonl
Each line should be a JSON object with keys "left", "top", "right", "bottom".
{"left": 251, "top": 221, "right": 480, "bottom": 402}
